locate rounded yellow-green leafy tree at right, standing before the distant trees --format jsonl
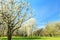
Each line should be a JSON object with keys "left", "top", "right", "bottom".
{"left": 45, "top": 23, "right": 57, "bottom": 36}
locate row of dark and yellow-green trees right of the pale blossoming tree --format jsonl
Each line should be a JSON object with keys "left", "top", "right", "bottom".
{"left": 34, "top": 22, "right": 60, "bottom": 37}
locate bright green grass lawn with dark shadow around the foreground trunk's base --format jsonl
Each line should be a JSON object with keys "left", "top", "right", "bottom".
{"left": 0, "top": 37, "right": 60, "bottom": 40}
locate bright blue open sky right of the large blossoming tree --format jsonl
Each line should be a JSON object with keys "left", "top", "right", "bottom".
{"left": 28, "top": 0, "right": 60, "bottom": 27}
